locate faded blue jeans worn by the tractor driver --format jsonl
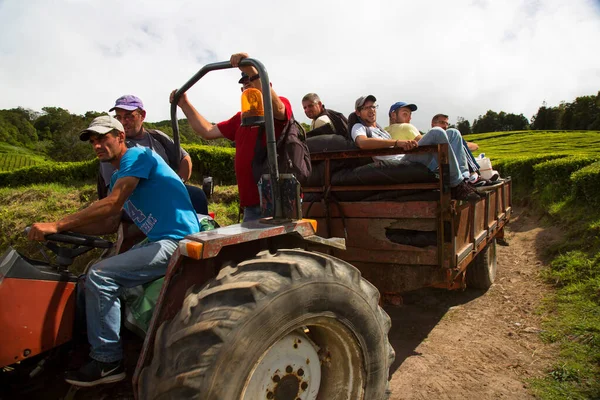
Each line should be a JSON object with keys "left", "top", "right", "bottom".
{"left": 84, "top": 239, "right": 178, "bottom": 362}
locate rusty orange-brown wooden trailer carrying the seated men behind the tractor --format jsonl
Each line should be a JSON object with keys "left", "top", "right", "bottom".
{"left": 303, "top": 144, "right": 512, "bottom": 293}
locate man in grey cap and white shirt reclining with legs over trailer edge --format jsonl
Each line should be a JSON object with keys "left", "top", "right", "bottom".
{"left": 351, "top": 95, "right": 480, "bottom": 200}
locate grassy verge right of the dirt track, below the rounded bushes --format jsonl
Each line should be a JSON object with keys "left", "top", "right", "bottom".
{"left": 520, "top": 197, "right": 600, "bottom": 400}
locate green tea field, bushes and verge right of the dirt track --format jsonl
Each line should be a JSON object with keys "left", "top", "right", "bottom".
{"left": 467, "top": 131, "right": 600, "bottom": 399}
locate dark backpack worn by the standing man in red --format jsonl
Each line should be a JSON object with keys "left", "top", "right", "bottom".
{"left": 252, "top": 115, "right": 312, "bottom": 185}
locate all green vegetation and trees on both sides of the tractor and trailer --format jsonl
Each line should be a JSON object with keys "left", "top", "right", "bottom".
{"left": 0, "top": 92, "right": 600, "bottom": 399}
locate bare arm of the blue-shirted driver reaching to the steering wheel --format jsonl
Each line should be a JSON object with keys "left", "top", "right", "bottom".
{"left": 28, "top": 176, "right": 139, "bottom": 241}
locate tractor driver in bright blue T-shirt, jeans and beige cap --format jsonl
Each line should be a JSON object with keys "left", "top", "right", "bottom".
{"left": 28, "top": 115, "right": 200, "bottom": 387}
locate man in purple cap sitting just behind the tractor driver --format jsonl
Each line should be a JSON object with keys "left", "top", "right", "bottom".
{"left": 98, "top": 94, "right": 208, "bottom": 215}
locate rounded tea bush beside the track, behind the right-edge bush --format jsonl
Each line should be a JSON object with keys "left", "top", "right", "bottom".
{"left": 533, "top": 157, "right": 599, "bottom": 204}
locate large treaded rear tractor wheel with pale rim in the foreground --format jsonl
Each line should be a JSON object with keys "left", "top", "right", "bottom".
{"left": 138, "top": 250, "right": 394, "bottom": 400}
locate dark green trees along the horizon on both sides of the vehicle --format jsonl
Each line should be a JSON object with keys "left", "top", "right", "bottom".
{"left": 0, "top": 91, "right": 600, "bottom": 161}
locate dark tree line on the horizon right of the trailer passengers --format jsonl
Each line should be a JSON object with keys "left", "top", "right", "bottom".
{"left": 455, "top": 91, "right": 600, "bottom": 135}
